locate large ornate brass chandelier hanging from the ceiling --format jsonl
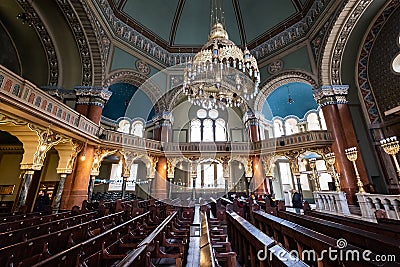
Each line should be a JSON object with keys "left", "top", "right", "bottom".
{"left": 182, "top": 0, "right": 260, "bottom": 109}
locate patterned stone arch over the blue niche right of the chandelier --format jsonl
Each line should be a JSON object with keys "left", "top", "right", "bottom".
{"left": 254, "top": 71, "right": 317, "bottom": 112}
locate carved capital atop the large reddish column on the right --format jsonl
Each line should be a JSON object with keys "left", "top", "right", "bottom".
{"left": 313, "top": 84, "right": 349, "bottom": 107}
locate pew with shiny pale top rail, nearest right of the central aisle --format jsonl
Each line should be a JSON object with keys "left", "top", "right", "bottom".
{"left": 226, "top": 210, "right": 308, "bottom": 267}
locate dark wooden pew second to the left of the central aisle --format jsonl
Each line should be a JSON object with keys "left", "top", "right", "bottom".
{"left": 33, "top": 212, "right": 149, "bottom": 267}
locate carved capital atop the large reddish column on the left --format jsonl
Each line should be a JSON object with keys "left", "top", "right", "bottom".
{"left": 74, "top": 86, "right": 112, "bottom": 107}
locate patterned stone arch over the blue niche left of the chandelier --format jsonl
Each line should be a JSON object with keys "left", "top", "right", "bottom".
{"left": 104, "top": 70, "right": 166, "bottom": 113}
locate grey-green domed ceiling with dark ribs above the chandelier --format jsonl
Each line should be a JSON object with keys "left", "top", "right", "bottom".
{"left": 108, "top": 0, "right": 313, "bottom": 52}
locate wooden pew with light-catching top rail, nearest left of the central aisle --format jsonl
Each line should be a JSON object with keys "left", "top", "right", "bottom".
{"left": 115, "top": 212, "right": 183, "bottom": 267}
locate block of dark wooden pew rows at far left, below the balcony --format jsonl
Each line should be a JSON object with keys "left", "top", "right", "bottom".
{"left": 0, "top": 198, "right": 156, "bottom": 266}
